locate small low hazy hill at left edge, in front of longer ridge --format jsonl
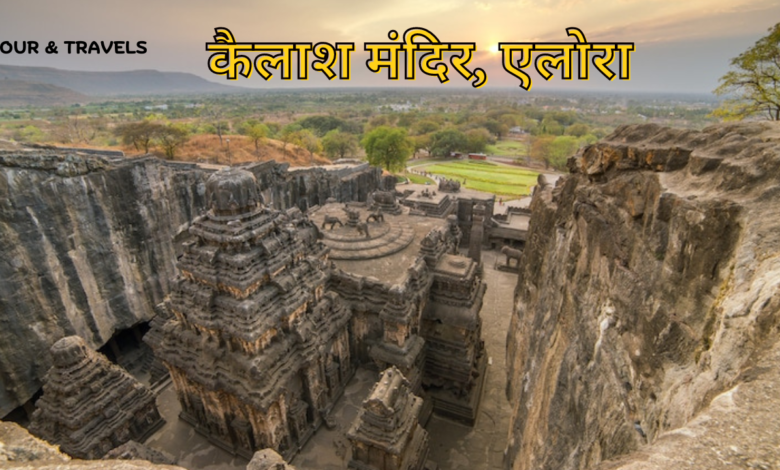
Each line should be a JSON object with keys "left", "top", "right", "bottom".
{"left": 0, "top": 78, "right": 91, "bottom": 108}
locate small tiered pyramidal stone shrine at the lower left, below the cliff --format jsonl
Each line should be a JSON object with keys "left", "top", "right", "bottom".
{"left": 30, "top": 336, "right": 163, "bottom": 459}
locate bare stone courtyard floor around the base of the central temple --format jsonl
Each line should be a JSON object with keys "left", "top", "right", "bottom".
{"left": 141, "top": 251, "right": 517, "bottom": 470}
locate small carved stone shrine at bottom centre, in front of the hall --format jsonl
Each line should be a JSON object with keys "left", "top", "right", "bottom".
{"left": 347, "top": 367, "right": 428, "bottom": 470}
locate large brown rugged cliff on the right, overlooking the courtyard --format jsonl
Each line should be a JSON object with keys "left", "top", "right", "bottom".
{"left": 507, "top": 123, "right": 780, "bottom": 469}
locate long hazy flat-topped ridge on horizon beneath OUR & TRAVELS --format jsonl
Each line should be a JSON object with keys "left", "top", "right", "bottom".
{"left": 0, "top": 65, "right": 242, "bottom": 96}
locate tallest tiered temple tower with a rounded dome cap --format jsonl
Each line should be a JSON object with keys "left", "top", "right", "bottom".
{"left": 155, "top": 169, "right": 356, "bottom": 458}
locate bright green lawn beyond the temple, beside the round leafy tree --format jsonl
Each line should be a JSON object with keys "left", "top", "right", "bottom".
{"left": 425, "top": 161, "right": 539, "bottom": 197}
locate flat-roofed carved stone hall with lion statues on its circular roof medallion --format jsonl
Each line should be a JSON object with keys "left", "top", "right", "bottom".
{"left": 312, "top": 193, "right": 487, "bottom": 425}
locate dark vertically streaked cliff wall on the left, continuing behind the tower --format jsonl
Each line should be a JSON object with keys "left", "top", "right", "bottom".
{"left": 0, "top": 149, "right": 381, "bottom": 416}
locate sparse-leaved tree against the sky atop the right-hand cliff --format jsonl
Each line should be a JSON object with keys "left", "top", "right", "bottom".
{"left": 713, "top": 23, "right": 780, "bottom": 121}
